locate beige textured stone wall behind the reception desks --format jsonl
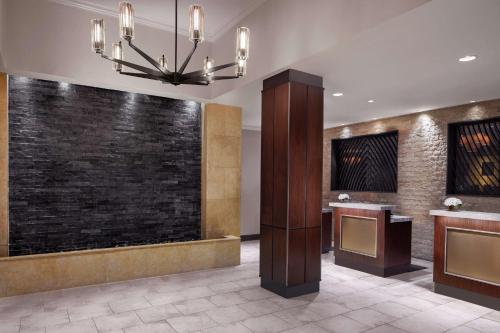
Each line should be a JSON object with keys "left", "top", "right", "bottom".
{"left": 323, "top": 100, "right": 500, "bottom": 260}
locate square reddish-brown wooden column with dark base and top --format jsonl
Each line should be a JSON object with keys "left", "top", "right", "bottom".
{"left": 260, "top": 70, "right": 323, "bottom": 297}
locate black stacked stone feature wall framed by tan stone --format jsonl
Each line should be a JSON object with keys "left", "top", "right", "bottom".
{"left": 9, "top": 76, "right": 201, "bottom": 256}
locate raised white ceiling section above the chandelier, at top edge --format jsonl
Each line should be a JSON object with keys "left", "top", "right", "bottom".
{"left": 51, "top": 0, "right": 267, "bottom": 41}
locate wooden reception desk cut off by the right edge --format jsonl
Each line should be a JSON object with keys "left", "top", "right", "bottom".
{"left": 430, "top": 210, "right": 500, "bottom": 310}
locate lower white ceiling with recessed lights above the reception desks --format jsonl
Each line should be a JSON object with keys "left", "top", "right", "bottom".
{"left": 217, "top": 0, "right": 500, "bottom": 128}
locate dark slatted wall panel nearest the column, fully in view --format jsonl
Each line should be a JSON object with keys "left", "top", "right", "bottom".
{"left": 331, "top": 132, "right": 398, "bottom": 192}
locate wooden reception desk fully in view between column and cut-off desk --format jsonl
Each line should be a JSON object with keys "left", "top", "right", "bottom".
{"left": 330, "top": 202, "right": 412, "bottom": 277}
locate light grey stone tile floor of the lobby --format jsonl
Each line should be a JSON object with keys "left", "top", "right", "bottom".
{"left": 0, "top": 242, "right": 500, "bottom": 333}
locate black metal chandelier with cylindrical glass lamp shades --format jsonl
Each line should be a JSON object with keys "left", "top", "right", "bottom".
{"left": 91, "top": 0, "right": 250, "bottom": 86}
